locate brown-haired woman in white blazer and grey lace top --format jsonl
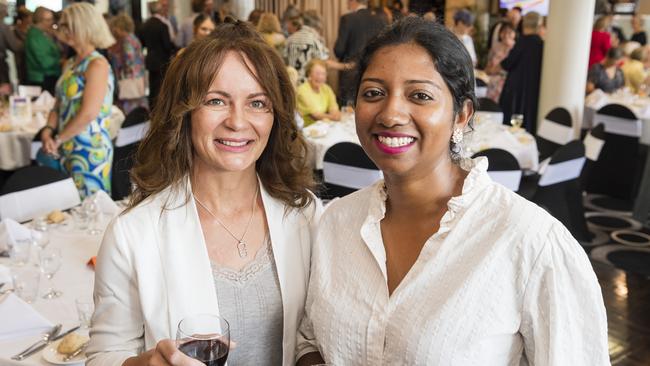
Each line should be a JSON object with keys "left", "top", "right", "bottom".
{"left": 88, "top": 23, "right": 320, "bottom": 365}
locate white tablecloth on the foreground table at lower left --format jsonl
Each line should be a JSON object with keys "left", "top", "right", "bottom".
{"left": 0, "top": 215, "right": 109, "bottom": 366}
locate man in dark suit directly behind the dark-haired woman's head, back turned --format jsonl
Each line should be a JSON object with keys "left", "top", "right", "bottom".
{"left": 334, "top": 0, "right": 388, "bottom": 106}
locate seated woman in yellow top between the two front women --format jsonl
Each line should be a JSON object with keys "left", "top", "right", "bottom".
{"left": 297, "top": 59, "right": 341, "bottom": 127}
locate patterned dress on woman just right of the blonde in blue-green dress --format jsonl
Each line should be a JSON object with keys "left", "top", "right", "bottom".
{"left": 108, "top": 33, "right": 149, "bottom": 114}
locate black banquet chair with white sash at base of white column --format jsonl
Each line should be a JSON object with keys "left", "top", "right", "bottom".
{"left": 535, "top": 107, "right": 575, "bottom": 161}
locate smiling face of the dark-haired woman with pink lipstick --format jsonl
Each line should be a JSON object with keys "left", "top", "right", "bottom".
{"left": 355, "top": 44, "right": 472, "bottom": 176}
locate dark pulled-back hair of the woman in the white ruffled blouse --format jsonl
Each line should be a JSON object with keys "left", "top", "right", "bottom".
{"left": 355, "top": 17, "right": 478, "bottom": 161}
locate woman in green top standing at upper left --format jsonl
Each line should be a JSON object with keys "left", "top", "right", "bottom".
{"left": 25, "top": 6, "right": 61, "bottom": 94}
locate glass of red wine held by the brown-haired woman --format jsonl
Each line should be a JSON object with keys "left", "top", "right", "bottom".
{"left": 176, "top": 314, "right": 230, "bottom": 366}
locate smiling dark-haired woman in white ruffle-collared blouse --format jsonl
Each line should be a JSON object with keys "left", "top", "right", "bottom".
{"left": 297, "top": 17, "right": 609, "bottom": 366}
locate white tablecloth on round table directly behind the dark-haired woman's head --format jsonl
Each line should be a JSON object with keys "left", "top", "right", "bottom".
{"left": 303, "top": 113, "right": 539, "bottom": 171}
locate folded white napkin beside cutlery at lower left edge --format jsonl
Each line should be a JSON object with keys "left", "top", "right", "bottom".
{"left": 0, "top": 293, "right": 52, "bottom": 341}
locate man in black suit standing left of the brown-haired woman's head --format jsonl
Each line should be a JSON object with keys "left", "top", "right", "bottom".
{"left": 137, "top": 2, "right": 176, "bottom": 108}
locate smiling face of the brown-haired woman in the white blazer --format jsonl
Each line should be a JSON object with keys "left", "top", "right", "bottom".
{"left": 191, "top": 51, "right": 273, "bottom": 172}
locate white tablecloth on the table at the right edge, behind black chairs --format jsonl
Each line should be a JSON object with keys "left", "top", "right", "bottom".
{"left": 582, "top": 89, "right": 650, "bottom": 145}
